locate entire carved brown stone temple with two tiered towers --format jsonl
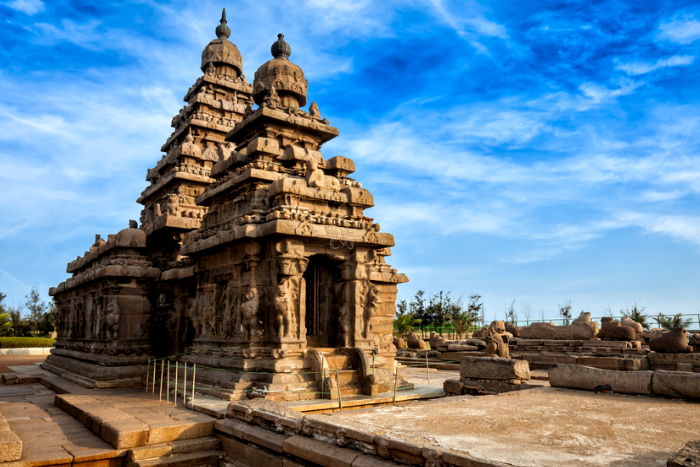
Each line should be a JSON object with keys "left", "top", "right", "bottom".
{"left": 44, "top": 11, "right": 408, "bottom": 400}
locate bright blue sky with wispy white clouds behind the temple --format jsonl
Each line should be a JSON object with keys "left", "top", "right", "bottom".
{"left": 0, "top": 0, "right": 700, "bottom": 318}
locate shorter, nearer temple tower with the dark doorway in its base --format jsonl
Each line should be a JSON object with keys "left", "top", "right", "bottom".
{"left": 181, "top": 34, "right": 407, "bottom": 398}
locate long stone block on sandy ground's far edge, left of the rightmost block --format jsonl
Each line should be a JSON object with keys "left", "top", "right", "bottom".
{"left": 549, "top": 364, "right": 652, "bottom": 394}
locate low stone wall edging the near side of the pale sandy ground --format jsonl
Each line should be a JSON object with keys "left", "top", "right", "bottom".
{"left": 215, "top": 399, "right": 506, "bottom": 467}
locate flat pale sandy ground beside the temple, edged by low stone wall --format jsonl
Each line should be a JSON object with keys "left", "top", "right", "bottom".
{"left": 332, "top": 387, "right": 700, "bottom": 466}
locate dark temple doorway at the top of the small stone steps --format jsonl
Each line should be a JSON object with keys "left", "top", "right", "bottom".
{"left": 304, "top": 255, "right": 341, "bottom": 347}
